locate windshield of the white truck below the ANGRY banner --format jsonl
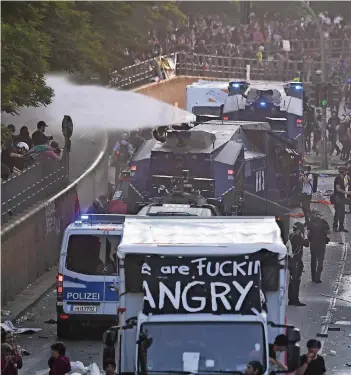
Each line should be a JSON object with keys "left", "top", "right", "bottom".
{"left": 139, "top": 322, "right": 266, "bottom": 374}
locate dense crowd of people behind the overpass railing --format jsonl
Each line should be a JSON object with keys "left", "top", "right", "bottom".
{"left": 125, "top": 13, "right": 351, "bottom": 65}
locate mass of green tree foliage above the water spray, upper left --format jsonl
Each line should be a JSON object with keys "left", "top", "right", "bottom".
{"left": 1, "top": 1, "right": 185, "bottom": 113}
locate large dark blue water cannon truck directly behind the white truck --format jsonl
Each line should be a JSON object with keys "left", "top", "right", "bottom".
{"left": 110, "top": 121, "right": 300, "bottom": 242}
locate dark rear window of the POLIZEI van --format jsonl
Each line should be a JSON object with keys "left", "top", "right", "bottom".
{"left": 66, "top": 234, "right": 121, "bottom": 275}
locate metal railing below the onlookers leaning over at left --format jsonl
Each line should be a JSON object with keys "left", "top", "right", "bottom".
{"left": 1, "top": 160, "right": 68, "bottom": 225}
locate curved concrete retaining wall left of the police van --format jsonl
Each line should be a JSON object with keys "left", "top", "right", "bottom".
{"left": 1, "top": 134, "right": 108, "bottom": 304}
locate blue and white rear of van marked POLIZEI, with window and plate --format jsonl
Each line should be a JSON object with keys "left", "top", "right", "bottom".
{"left": 60, "top": 231, "right": 121, "bottom": 320}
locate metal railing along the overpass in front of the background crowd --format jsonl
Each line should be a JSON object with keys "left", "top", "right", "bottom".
{"left": 110, "top": 39, "right": 351, "bottom": 90}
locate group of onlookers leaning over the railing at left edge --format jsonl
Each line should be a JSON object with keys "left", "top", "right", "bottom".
{"left": 1, "top": 121, "right": 62, "bottom": 181}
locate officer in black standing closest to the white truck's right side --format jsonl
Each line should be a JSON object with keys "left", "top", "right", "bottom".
{"left": 288, "top": 222, "right": 309, "bottom": 306}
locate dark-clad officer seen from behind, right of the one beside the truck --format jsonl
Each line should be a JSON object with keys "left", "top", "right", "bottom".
{"left": 307, "top": 210, "right": 330, "bottom": 284}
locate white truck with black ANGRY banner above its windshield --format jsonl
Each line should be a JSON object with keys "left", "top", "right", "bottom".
{"left": 104, "top": 216, "right": 300, "bottom": 375}
